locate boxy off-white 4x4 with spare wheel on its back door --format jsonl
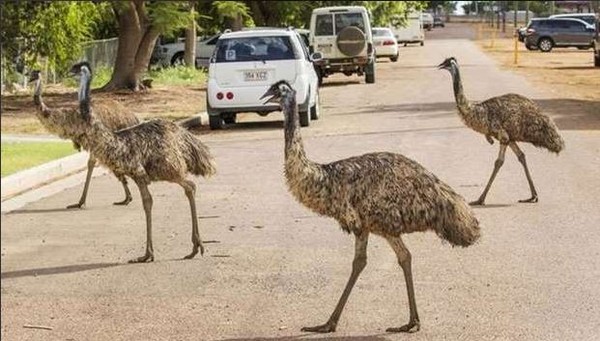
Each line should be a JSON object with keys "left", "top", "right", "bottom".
{"left": 310, "top": 6, "right": 375, "bottom": 83}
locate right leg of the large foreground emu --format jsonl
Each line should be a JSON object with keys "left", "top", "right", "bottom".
{"left": 386, "top": 237, "right": 421, "bottom": 333}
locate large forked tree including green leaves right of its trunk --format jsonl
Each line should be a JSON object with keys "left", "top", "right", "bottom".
{"left": 102, "top": 0, "right": 190, "bottom": 91}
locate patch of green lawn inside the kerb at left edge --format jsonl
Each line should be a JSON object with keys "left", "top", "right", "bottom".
{"left": 1, "top": 141, "right": 77, "bottom": 177}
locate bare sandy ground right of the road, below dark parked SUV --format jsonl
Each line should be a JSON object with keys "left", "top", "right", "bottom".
{"left": 477, "top": 33, "right": 600, "bottom": 130}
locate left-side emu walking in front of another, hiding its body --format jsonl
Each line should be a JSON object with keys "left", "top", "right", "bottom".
{"left": 71, "top": 63, "right": 215, "bottom": 263}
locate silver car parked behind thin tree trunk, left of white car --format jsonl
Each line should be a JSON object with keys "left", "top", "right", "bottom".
{"left": 150, "top": 33, "right": 221, "bottom": 67}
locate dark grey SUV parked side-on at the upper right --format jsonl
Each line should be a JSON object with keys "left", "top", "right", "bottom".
{"left": 525, "top": 18, "right": 596, "bottom": 52}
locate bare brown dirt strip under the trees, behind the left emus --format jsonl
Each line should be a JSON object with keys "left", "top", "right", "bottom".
{"left": 1, "top": 85, "right": 206, "bottom": 134}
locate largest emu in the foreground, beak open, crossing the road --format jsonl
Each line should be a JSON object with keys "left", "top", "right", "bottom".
{"left": 263, "top": 81, "right": 480, "bottom": 333}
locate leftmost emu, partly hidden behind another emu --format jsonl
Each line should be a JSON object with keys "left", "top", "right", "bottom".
{"left": 29, "top": 66, "right": 140, "bottom": 208}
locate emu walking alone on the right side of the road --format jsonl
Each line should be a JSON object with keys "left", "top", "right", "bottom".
{"left": 438, "top": 57, "right": 565, "bottom": 205}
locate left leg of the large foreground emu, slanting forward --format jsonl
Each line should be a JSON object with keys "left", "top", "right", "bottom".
{"left": 302, "top": 232, "right": 369, "bottom": 333}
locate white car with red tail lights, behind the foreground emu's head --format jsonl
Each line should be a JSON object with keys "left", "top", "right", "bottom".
{"left": 206, "top": 29, "right": 322, "bottom": 129}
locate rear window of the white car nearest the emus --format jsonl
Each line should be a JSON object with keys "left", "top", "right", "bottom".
{"left": 215, "top": 36, "right": 301, "bottom": 63}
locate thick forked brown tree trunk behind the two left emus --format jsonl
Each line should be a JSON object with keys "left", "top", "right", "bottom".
{"left": 101, "top": 0, "right": 159, "bottom": 91}
